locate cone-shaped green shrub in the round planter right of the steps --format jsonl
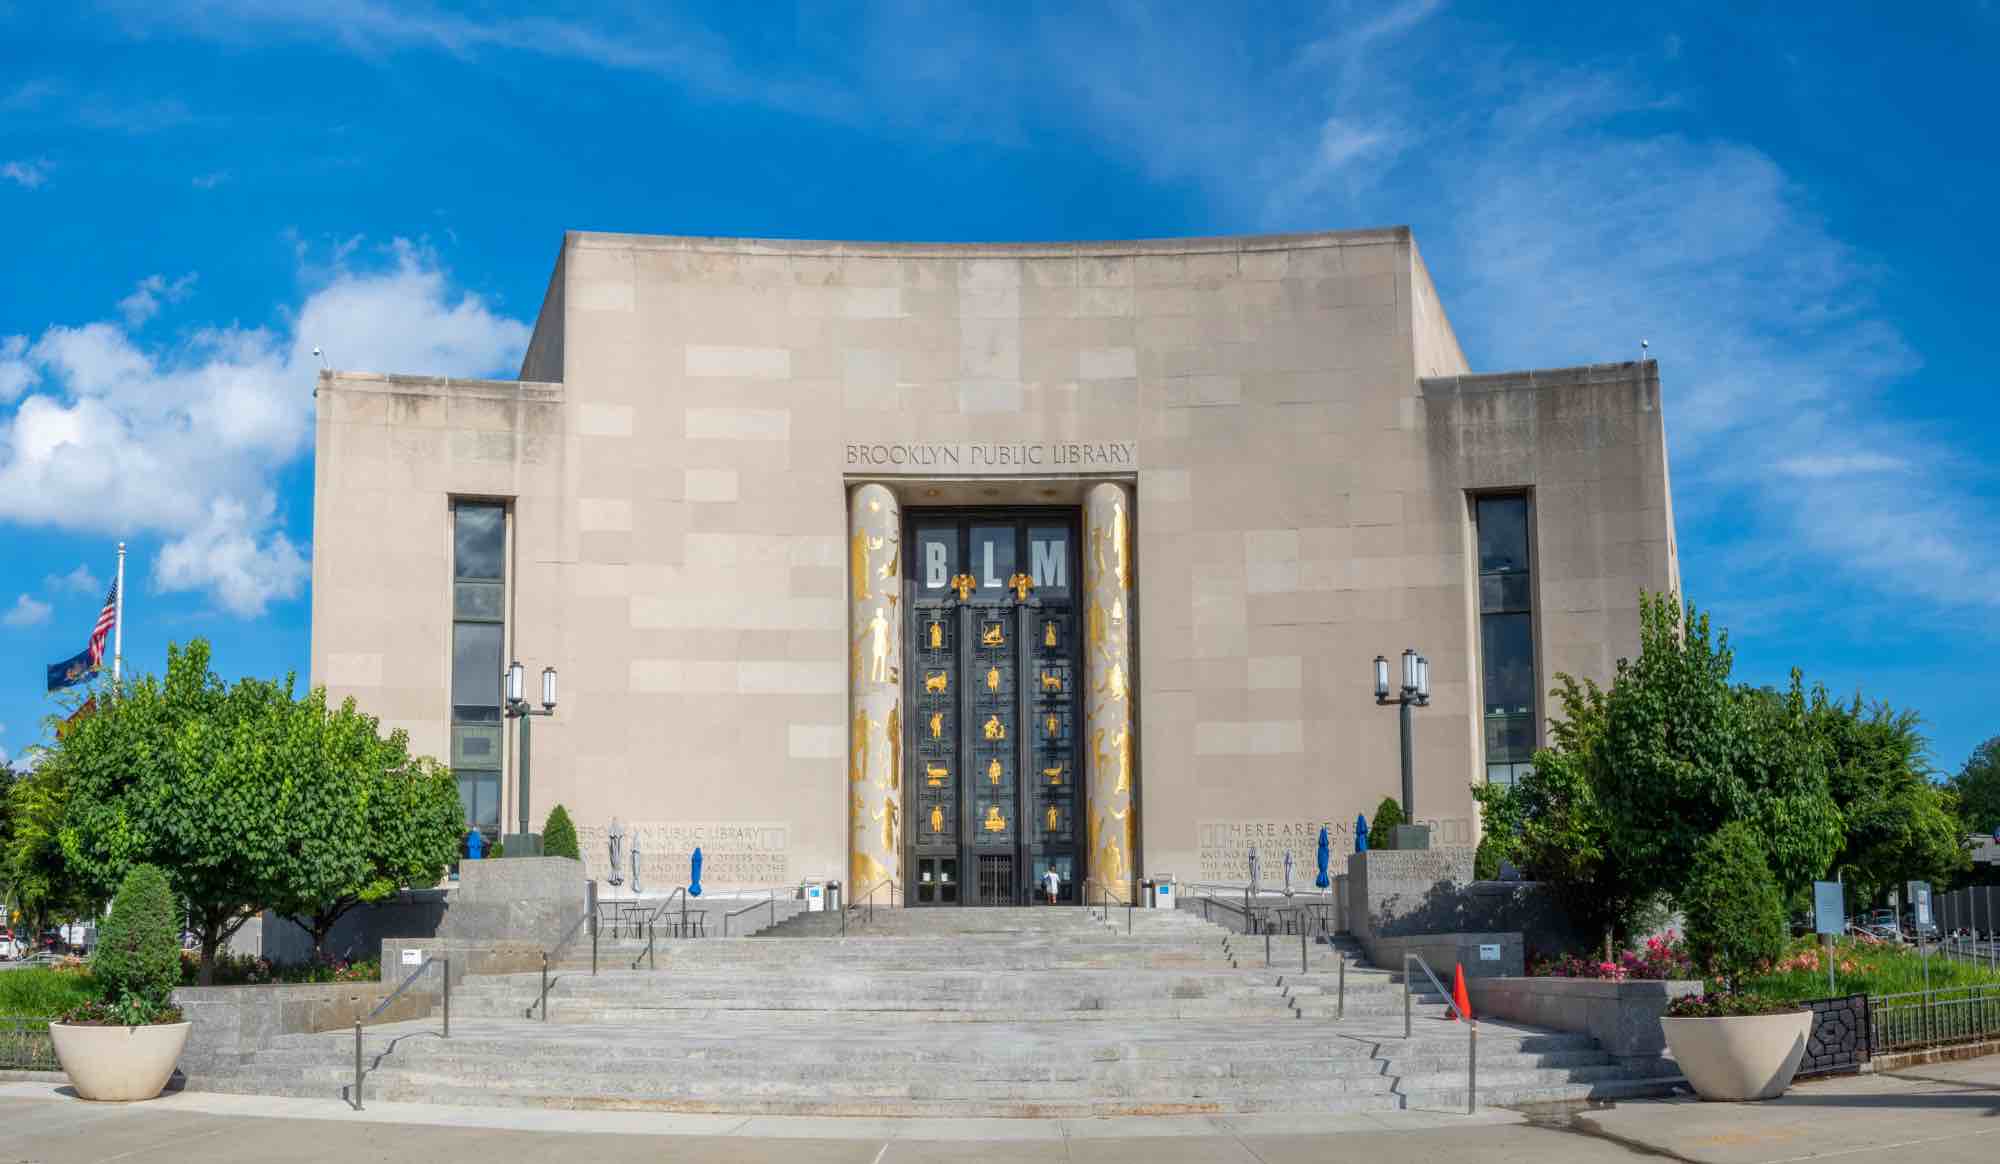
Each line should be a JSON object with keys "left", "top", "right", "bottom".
{"left": 1680, "top": 820, "right": 1786, "bottom": 990}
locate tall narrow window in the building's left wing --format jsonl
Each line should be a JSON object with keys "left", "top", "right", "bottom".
{"left": 452, "top": 502, "right": 506, "bottom": 842}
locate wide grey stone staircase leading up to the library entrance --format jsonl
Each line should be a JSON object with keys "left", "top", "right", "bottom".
{"left": 190, "top": 908, "right": 1660, "bottom": 1116}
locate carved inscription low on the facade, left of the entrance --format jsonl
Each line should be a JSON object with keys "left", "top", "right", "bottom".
{"left": 576, "top": 820, "right": 794, "bottom": 894}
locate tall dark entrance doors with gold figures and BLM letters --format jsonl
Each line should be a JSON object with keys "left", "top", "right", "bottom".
{"left": 904, "top": 510, "right": 1084, "bottom": 906}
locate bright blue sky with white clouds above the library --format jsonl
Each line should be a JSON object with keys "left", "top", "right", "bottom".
{"left": 0, "top": 0, "right": 2000, "bottom": 770}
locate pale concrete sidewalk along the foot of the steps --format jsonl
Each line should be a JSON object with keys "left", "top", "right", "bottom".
{"left": 0, "top": 1058, "right": 2000, "bottom": 1164}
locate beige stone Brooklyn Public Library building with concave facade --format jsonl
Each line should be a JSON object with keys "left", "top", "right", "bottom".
{"left": 312, "top": 228, "right": 1678, "bottom": 906}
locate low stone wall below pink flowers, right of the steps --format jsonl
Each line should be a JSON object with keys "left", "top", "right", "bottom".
{"left": 1466, "top": 974, "right": 1702, "bottom": 1072}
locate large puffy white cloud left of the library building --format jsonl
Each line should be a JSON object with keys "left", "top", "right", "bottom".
{"left": 0, "top": 240, "right": 528, "bottom": 616}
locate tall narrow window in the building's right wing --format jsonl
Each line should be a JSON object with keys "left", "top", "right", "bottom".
{"left": 1474, "top": 494, "right": 1540, "bottom": 784}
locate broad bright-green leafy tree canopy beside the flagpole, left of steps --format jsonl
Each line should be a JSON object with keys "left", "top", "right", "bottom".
{"left": 48, "top": 640, "right": 458, "bottom": 984}
